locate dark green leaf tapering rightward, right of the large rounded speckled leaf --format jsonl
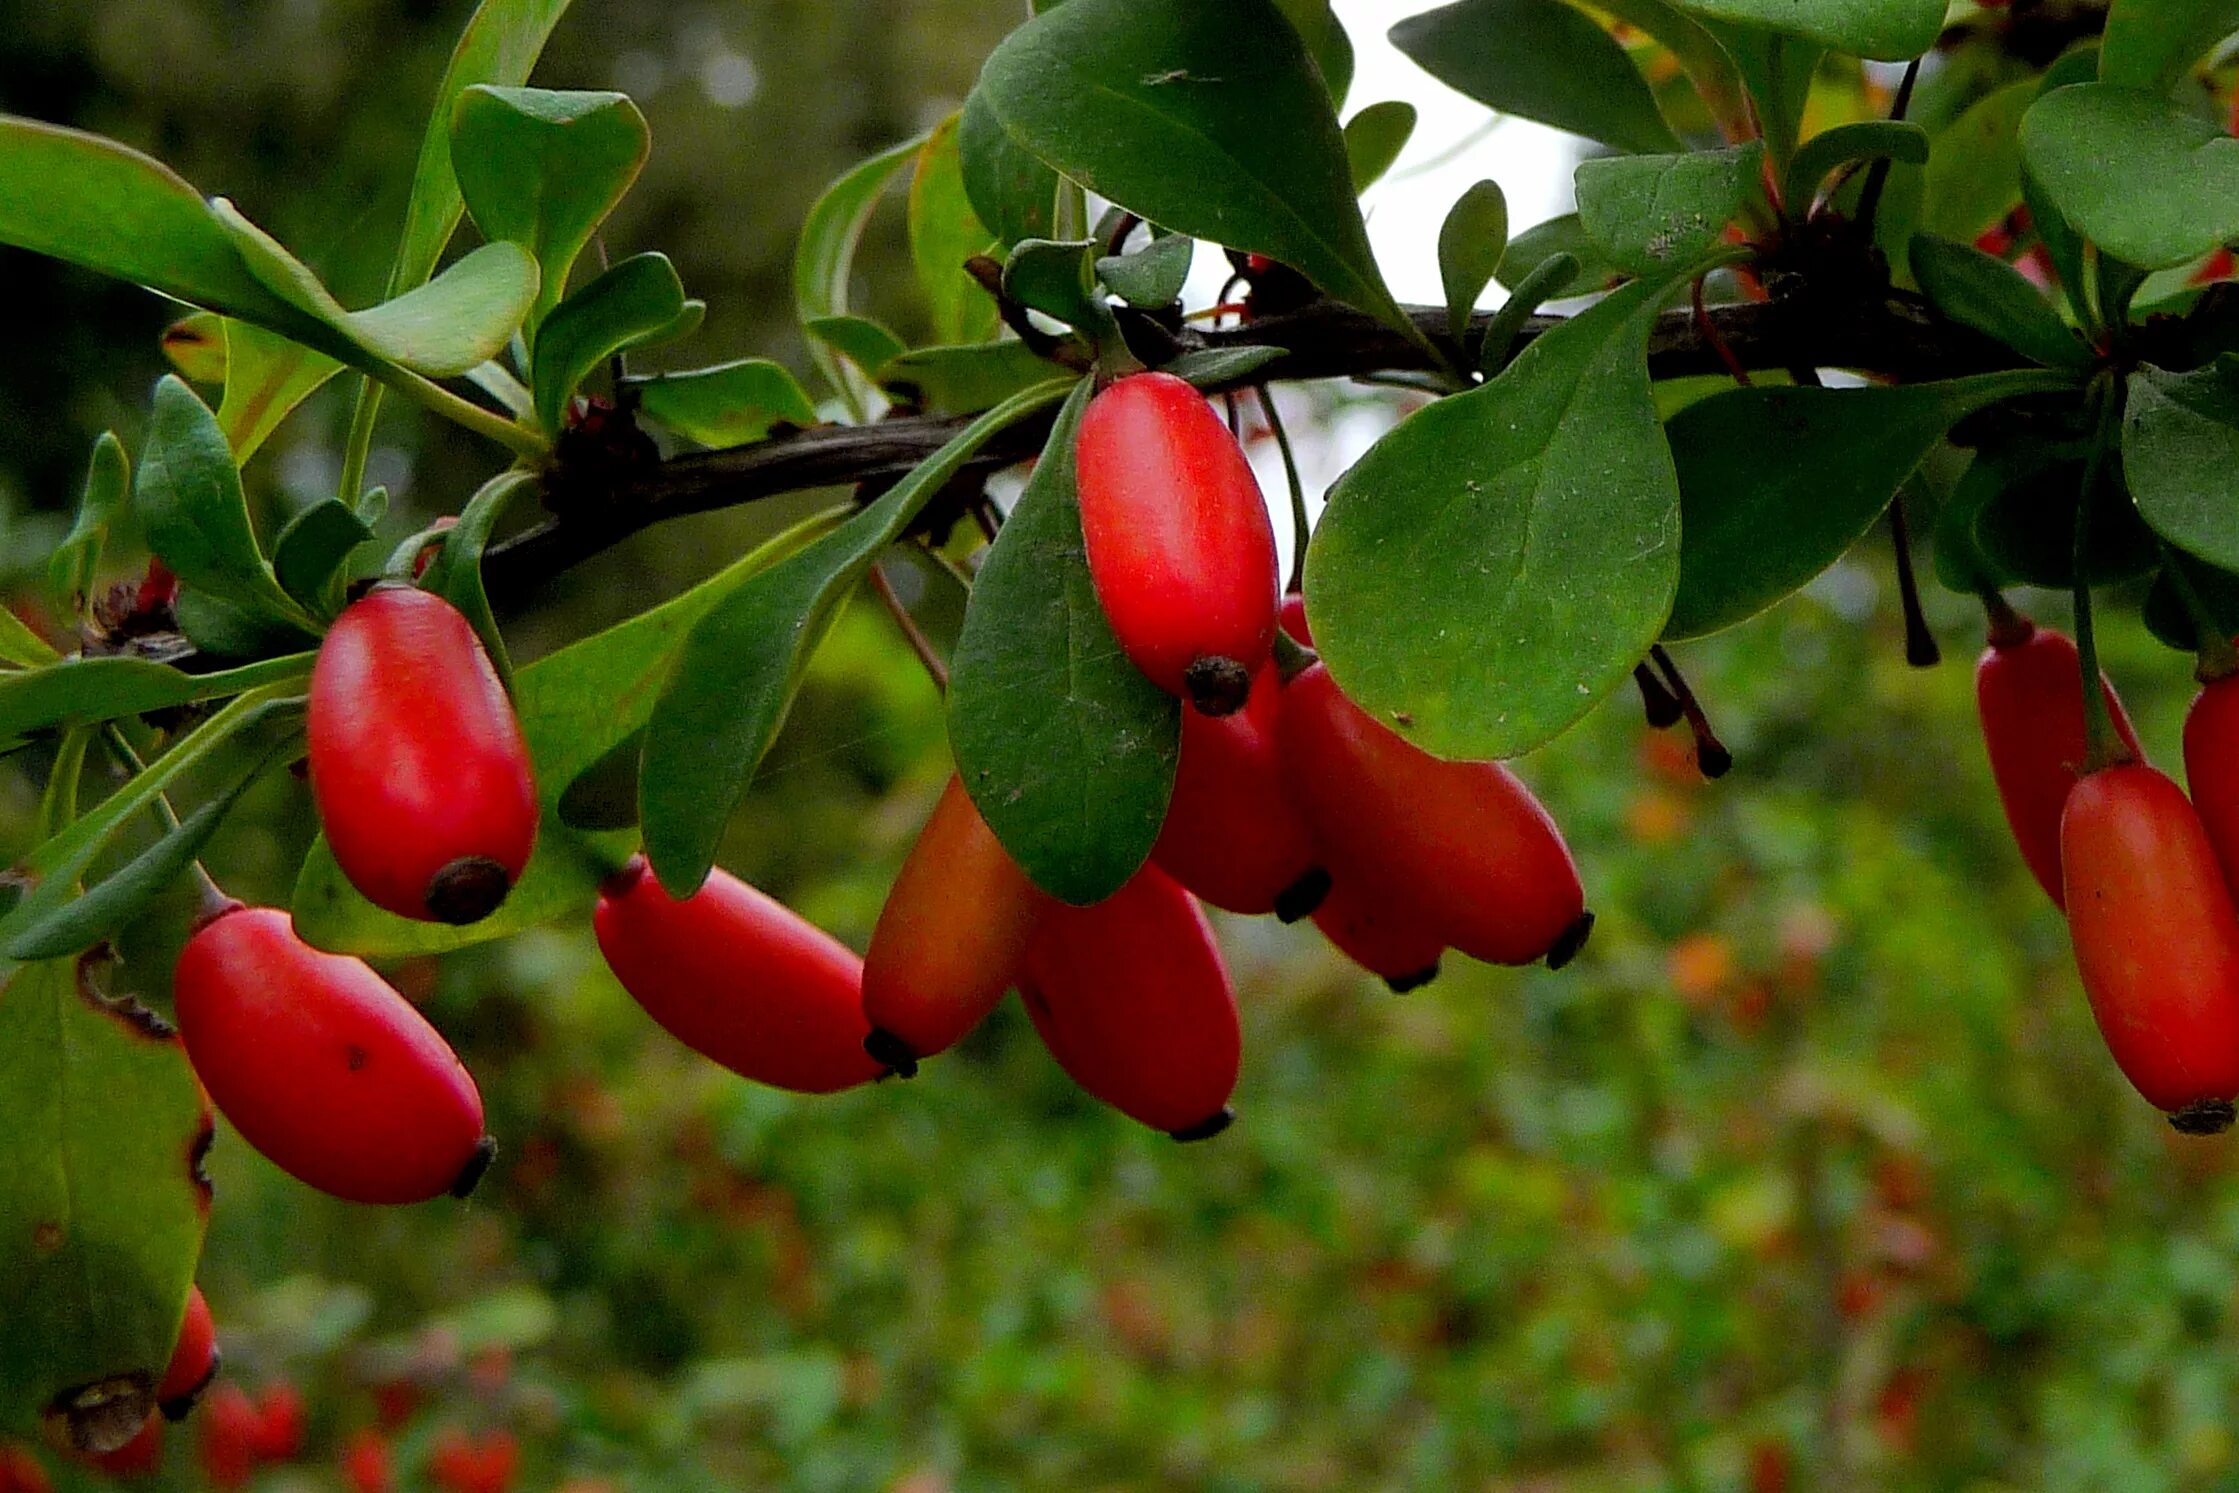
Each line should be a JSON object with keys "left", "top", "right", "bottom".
{"left": 1664, "top": 372, "right": 2073, "bottom": 638}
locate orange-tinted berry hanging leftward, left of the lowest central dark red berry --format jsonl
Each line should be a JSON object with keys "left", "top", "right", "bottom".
{"left": 862, "top": 777, "right": 1048, "bottom": 1077}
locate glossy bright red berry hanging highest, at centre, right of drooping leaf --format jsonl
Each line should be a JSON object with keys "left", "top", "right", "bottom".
{"left": 1075, "top": 374, "right": 1281, "bottom": 716}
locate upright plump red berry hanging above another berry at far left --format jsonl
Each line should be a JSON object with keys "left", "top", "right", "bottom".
{"left": 309, "top": 584, "right": 537, "bottom": 922}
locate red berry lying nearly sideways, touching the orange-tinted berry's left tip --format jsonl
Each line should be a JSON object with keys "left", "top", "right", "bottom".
{"left": 591, "top": 855, "right": 887, "bottom": 1095}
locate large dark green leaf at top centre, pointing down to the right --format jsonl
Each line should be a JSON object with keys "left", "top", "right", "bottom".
{"left": 981, "top": 0, "right": 1420, "bottom": 340}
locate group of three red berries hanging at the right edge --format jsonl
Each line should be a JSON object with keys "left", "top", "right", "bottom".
{"left": 1975, "top": 604, "right": 2239, "bottom": 1135}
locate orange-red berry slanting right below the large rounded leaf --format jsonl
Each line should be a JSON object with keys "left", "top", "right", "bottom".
{"left": 1278, "top": 663, "right": 1594, "bottom": 967}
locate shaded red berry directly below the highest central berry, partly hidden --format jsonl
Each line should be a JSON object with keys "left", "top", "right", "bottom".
{"left": 1151, "top": 663, "right": 1330, "bottom": 922}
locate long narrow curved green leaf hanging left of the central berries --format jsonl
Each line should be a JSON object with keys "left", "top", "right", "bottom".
{"left": 640, "top": 380, "right": 1088, "bottom": 895}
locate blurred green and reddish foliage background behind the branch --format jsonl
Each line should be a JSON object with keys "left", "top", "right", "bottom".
{"left": 0, "top": 0, "right": 2239, "bottom": 1493}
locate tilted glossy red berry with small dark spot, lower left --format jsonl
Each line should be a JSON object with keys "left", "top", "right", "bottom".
{"left": 175, "top": 907, "right": 495, "bottom": 1202}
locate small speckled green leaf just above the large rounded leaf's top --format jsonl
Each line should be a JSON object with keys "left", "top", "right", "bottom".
{"left": 1578, "top": 141, "right": 1764, "bottom": 275}
